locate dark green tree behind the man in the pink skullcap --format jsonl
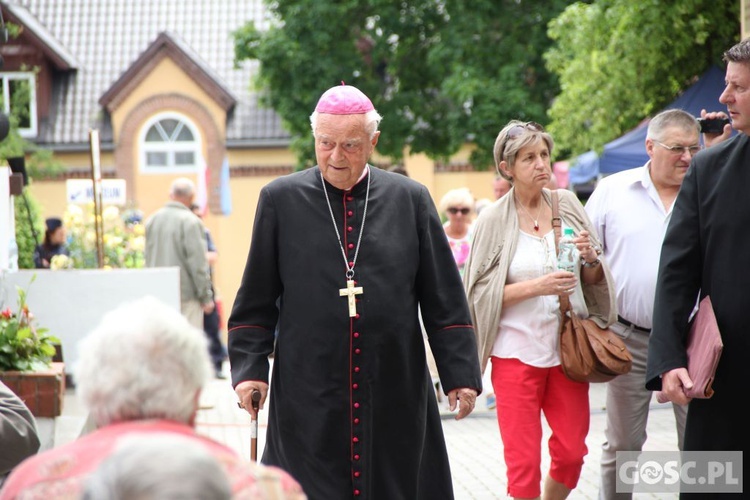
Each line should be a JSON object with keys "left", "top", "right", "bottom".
{"left": 235, "top": 0, "right": 571, "bottom": 168}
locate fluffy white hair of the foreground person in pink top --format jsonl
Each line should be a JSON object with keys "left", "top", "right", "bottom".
{"left": 74, "top": 297, "right": 211, "bottom": 427}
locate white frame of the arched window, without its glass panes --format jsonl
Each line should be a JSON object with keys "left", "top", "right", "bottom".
{"left": 138, "top": 111, "right": 204, "bottom": 174}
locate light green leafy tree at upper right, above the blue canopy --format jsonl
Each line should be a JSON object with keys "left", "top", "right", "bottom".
{"left": 545, "top": 0, "right": 740, "bottom": 160}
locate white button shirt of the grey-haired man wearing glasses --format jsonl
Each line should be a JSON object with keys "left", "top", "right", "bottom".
{"left": 585, "top": 161, "right": 674, "bottom": 328}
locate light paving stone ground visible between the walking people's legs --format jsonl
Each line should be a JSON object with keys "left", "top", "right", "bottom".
{"left": 197, "top": 366, "right": 688, "bottom": 500}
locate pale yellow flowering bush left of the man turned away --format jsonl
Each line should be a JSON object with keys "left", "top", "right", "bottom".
{"left": 64, "top": 203, "right": 146, "bottom": 269}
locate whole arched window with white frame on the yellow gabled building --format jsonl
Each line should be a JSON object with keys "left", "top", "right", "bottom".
{"left": 140, "top": 113, "right": 203, "bottom": 174}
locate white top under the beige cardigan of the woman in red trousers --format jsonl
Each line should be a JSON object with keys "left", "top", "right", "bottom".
{"left": 492, "top": 230, "right": 588, "bottom": 368}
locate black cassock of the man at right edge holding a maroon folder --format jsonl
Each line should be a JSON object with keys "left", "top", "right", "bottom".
{"left": 648, "top": 134, "right": 750, "bottom": 498}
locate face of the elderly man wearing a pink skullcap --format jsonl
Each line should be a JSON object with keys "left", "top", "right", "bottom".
{"left": 315, "top": 113, "right": 380, "bottom": 189}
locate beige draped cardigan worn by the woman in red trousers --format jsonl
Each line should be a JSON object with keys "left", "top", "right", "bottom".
{"left": 463, "top": 188, "right": 617, "bottom": 373}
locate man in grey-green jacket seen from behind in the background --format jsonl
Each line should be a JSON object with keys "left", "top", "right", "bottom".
{"left": 146, "top": 177, "right": 214, "bottom": 330}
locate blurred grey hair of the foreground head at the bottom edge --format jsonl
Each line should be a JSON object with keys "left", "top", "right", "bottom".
{"left": 81, "top": 434, "right": 232, "bottom": 500}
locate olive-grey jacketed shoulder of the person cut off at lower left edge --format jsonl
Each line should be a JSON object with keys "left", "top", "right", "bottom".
{"left": 0, "top": 382, "right": 39, "bottom": 486}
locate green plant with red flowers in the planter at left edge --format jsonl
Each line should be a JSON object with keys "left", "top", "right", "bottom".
{"left": 0, "top": 275, "right": 60, "bottom": 371}
